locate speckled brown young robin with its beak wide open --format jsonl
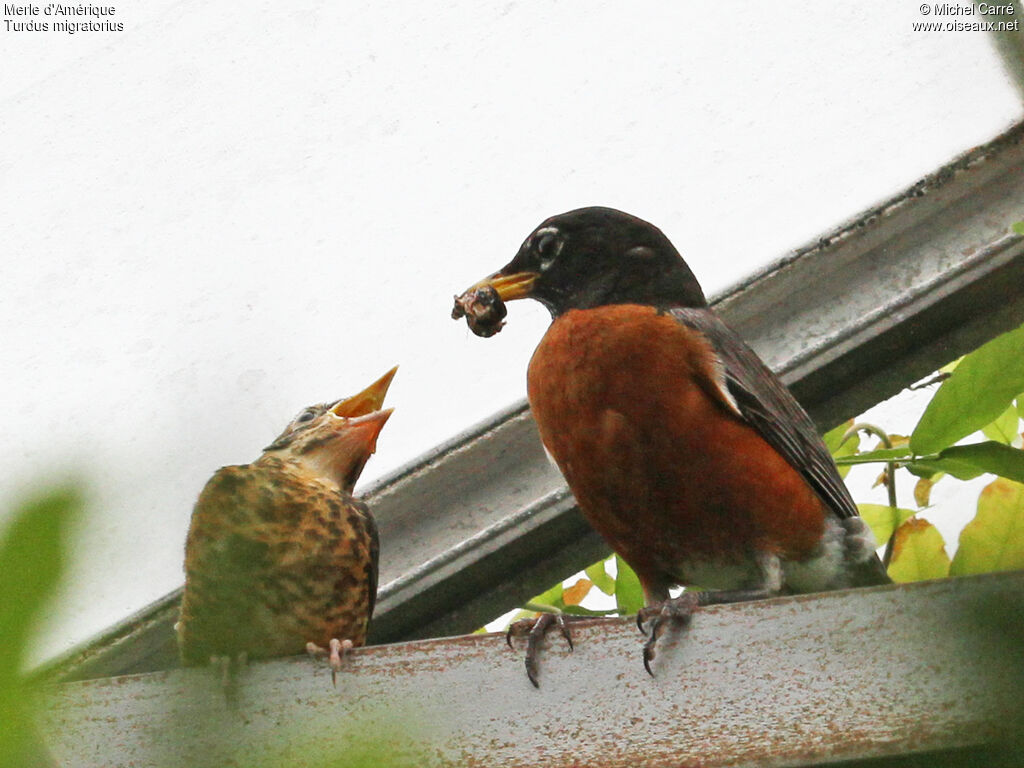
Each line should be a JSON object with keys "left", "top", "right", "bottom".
{"left": 176, "top": 369, "right": 396, "bottom": 687}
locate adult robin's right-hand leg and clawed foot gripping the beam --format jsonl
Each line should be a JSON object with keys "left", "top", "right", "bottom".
{"left": 637, "top": 555, "right": 782, "bottom": 677}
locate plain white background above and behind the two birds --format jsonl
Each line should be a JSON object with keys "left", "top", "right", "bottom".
{"left": 0, "top": 0, "right": 1021, "bottom": 654}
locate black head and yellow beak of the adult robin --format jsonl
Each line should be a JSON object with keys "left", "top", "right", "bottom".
{"left": 462, "top": 208, "right": 708, "bottom": 325}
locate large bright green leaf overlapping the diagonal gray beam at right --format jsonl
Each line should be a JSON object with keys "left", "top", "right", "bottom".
{"left": 910, "top": 326, "right": 1024, "bottom": 455}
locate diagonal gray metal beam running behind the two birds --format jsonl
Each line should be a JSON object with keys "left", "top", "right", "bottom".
{"left": 44, "top": 118, "right": 1024, "bottom": 680}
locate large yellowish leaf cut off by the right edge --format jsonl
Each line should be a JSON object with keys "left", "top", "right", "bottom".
{"left": 949, "top": 477, "right": 1024, "bottom": 575}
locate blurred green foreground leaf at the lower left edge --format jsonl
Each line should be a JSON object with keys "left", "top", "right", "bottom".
{"left": 0, "top": 487, "right": 82, "bottom": 766}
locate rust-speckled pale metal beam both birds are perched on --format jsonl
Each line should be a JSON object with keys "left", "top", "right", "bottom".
{"left": 41, "top": 571, "right": 1024, "bottom": 768}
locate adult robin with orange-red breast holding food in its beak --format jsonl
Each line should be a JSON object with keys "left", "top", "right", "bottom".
{"left": 453, "top": 208, "right": 889, "bottom": 684}
